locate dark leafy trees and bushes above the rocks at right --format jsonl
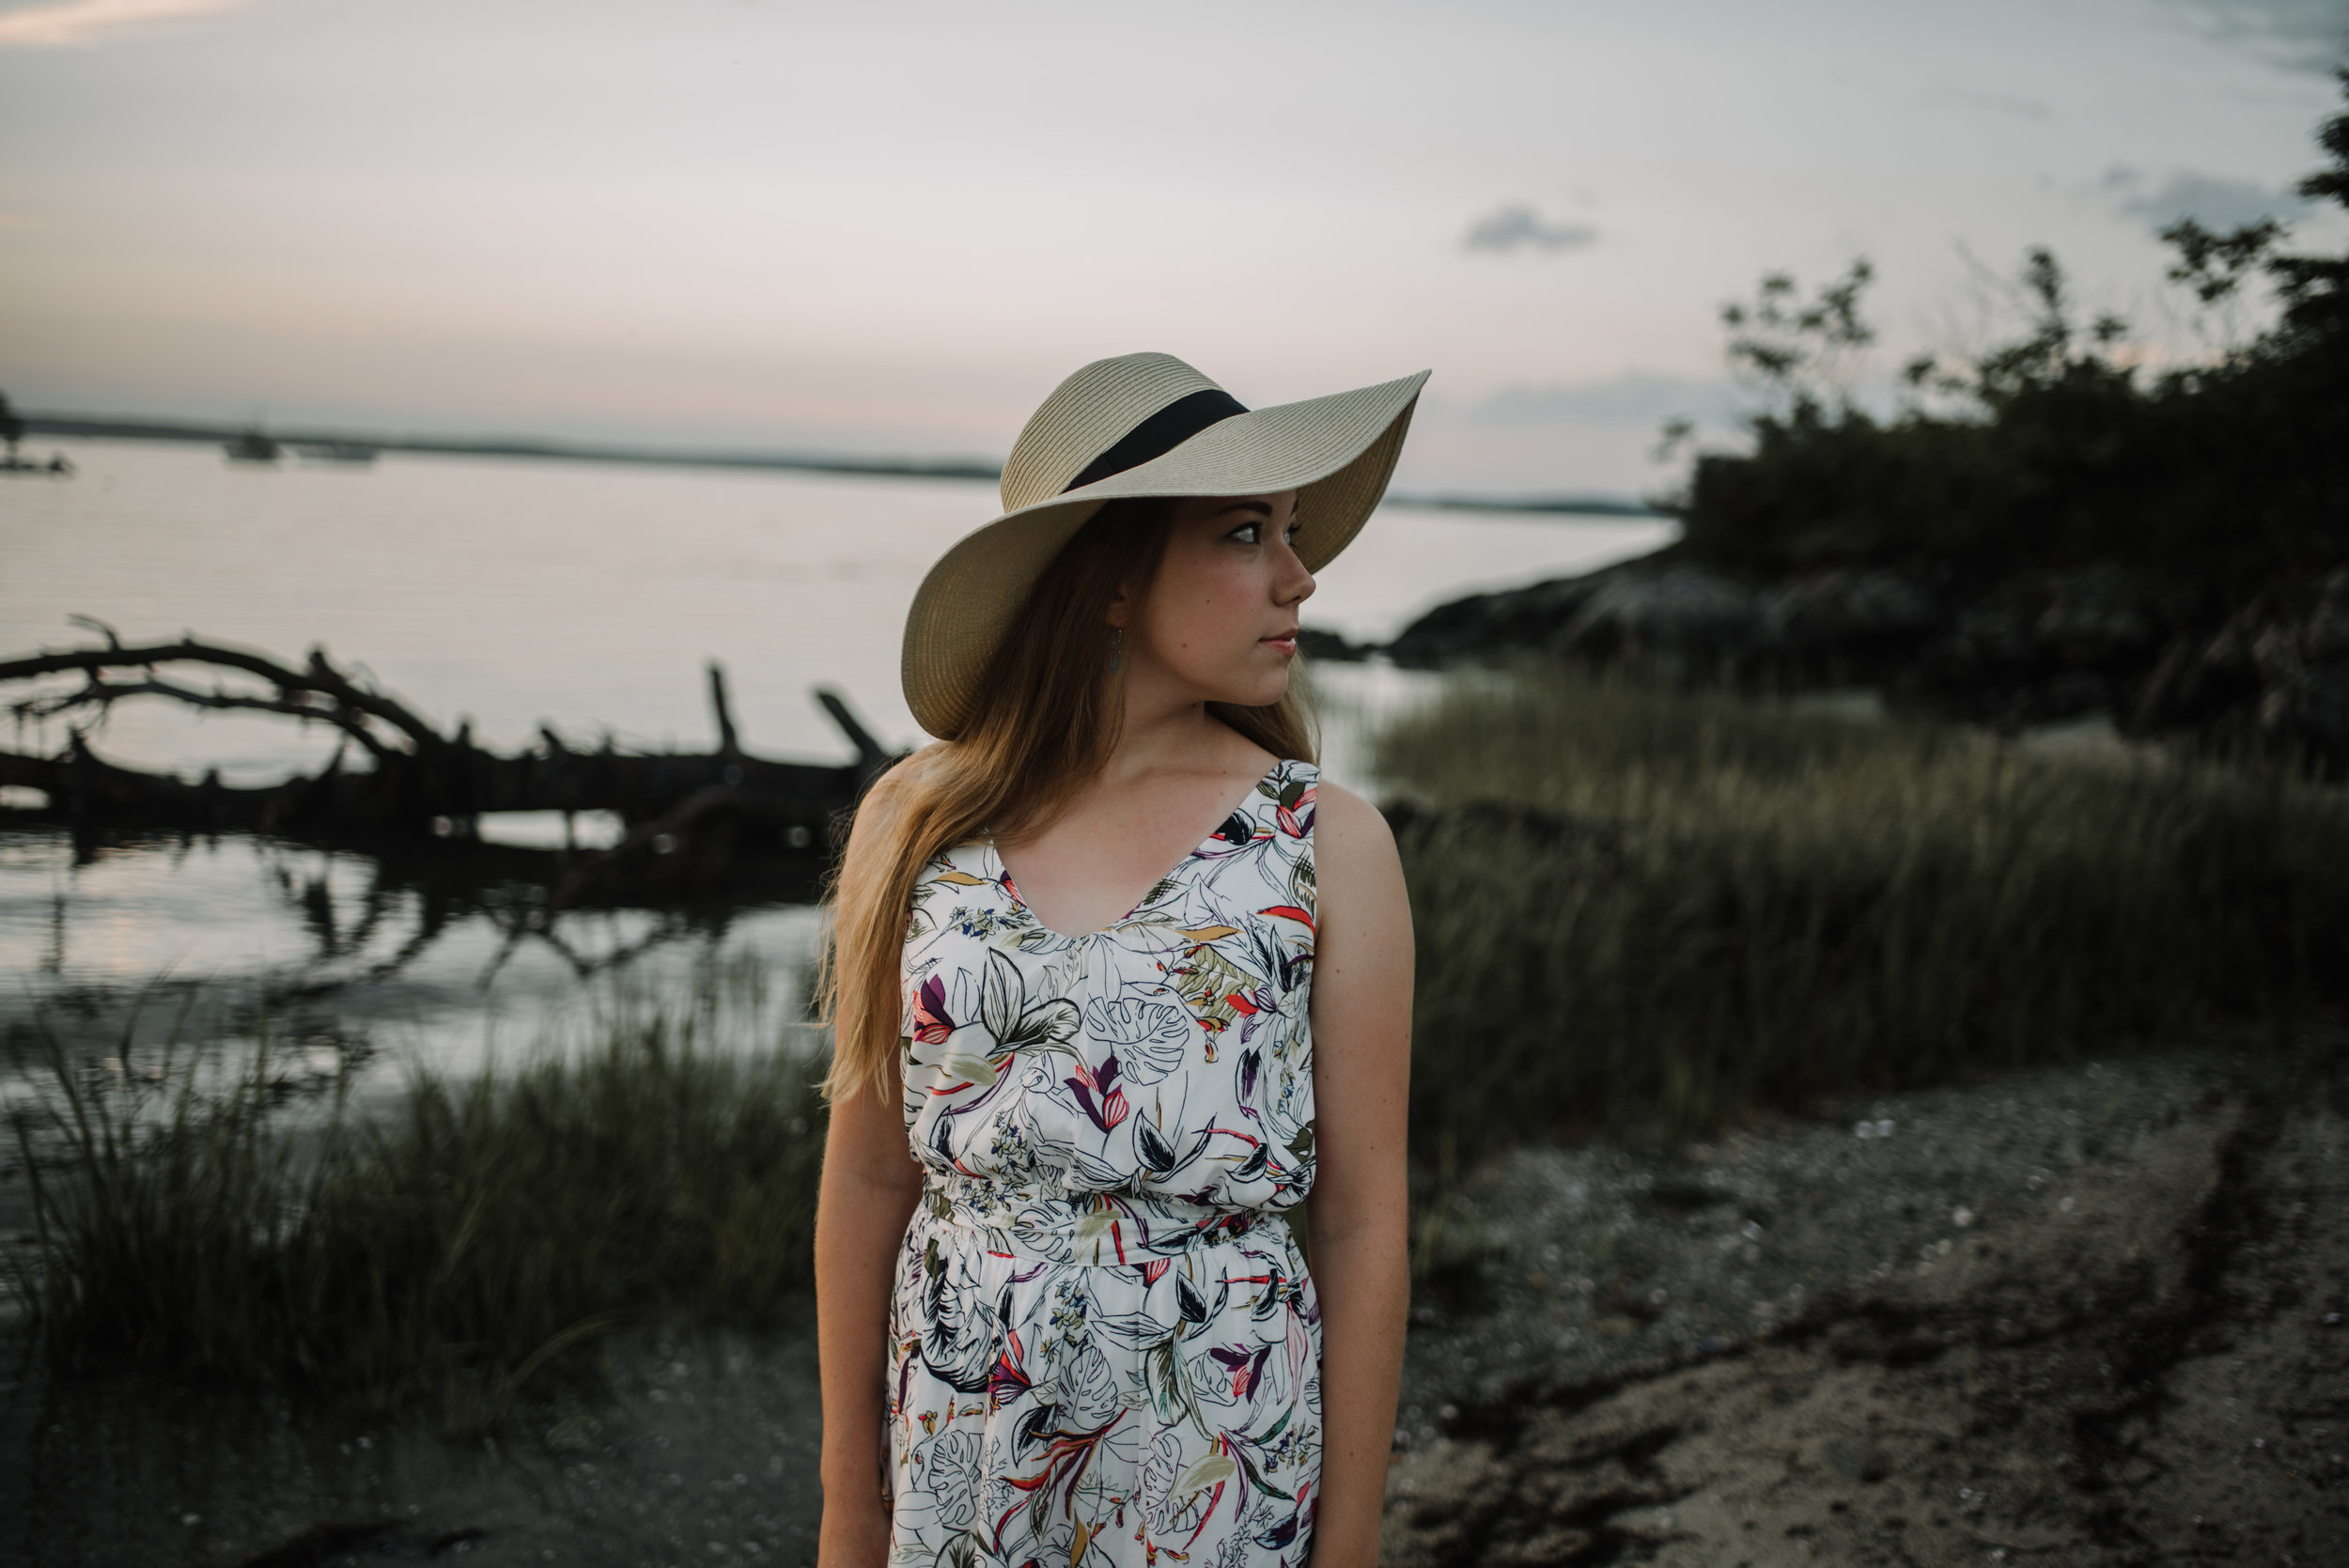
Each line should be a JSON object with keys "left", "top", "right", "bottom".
{"left": 1668, "top": 70, "right": 2349, "bottom": 594}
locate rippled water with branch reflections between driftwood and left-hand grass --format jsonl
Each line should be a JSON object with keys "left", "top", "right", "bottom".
{"left": 0, "top": 829, "right": 817, "bottom": 1103}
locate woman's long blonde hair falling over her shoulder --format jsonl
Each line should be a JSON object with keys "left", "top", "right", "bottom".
{"left": 816, "top": 500, "right": 1318, "bottom": 1101}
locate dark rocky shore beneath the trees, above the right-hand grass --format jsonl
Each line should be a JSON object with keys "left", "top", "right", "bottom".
{"left": 1306, "top": 545, "right": 2349, "bottom": 766}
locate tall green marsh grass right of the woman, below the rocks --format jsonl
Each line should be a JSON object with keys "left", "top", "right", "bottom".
{"left": 1372, "top": 669, "right": 2349, "bottom": 1141}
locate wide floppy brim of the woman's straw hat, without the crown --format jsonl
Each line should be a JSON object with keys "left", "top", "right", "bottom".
{"left": 902, "top": 371, "right": 1428, "bottom": 739}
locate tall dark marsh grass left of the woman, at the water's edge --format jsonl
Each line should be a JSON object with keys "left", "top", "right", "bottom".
{"left": 14, "top": 967, "right": 822, "bottom": 1427}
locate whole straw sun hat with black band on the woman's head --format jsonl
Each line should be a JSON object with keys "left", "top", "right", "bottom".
{"left": 905, "top": 354, "right": 1428, "bottom": 739}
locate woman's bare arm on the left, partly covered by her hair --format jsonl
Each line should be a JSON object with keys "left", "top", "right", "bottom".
{"left": 816, "top": 780, "right": 921, "bottom": 1568}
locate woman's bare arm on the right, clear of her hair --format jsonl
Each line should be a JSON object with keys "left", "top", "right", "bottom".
{"left": 1309, "top": 782, "right": 1412, "bottom": 1568}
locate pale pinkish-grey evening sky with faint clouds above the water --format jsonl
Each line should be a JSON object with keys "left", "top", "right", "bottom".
{"left": 0, "top": 0, "right": 2349, "bottom": 493}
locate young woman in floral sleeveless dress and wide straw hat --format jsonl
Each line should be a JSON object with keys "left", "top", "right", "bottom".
{"left": 816, "top": 354, "right": 1426, "bottom": 1568}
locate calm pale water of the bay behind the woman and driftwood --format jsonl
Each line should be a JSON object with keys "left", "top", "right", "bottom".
{"left": 0, "top": 442, "right": 1671, "bottom": 1070}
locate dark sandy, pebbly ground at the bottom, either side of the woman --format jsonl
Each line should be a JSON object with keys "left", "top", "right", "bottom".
{"left": 0, "top": 1031, "right": 2349, "bottom": 1568}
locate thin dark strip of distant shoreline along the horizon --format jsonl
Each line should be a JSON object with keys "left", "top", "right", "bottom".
{"left": 23, "top": 413, "right": 1666, "bottom": 519}
